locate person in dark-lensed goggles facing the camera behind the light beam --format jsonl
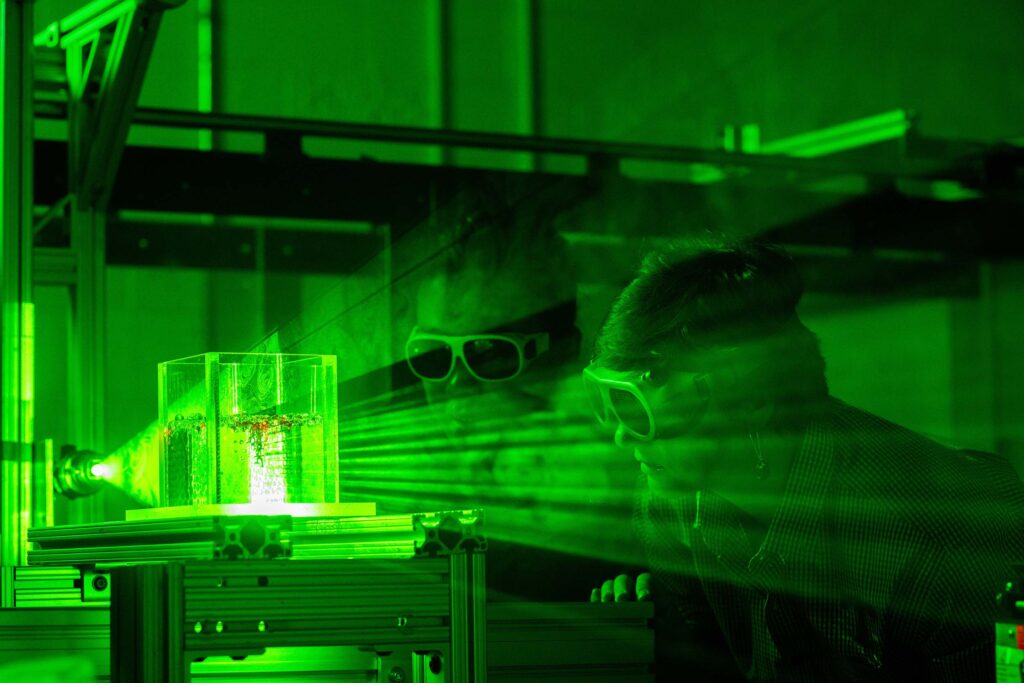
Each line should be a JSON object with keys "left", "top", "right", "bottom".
{"left": 406, "top": 185, "right": 632, "bottom": 600}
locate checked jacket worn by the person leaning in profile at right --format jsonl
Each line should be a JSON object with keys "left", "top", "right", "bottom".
{"left": 635, "top": 399, "right": 1024, "bottom": 683}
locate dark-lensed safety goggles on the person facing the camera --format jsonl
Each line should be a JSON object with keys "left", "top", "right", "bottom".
{"left": 406, "top": 329, "right": 551, "bottom": 382}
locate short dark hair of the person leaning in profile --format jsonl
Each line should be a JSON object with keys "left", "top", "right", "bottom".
{"left": 596, "top": 239, "right": 828, "bottom": 421}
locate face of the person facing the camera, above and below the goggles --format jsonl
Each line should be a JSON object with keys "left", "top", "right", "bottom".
{"left": 417, "top": 269, "right": 545, "bottom": 437}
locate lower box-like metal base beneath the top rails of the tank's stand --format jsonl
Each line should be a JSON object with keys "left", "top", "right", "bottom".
{"left": 111, "top": 553, "right": 486, "bottom": 683}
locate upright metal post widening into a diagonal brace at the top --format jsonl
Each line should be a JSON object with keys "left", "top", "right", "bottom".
{"left": 29, "top": 0, "right": 184, "bottom": 485}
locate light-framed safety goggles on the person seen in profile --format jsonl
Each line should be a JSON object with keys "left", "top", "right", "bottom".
{"left": 583, "top": 365, "right": 711, "bottom": 441}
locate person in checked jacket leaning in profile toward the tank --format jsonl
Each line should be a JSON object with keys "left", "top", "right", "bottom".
{"left": 585, "top": 237, "right": 1024, "bottom": 682}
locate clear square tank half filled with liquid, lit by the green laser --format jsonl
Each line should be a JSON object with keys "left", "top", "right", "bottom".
{"left": 159, "top": 353, "right": 339, "bottom": 507}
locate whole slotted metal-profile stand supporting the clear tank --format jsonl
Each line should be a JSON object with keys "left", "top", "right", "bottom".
{"left": 24, "top": 510, "right": 486, "bottom": 683}
